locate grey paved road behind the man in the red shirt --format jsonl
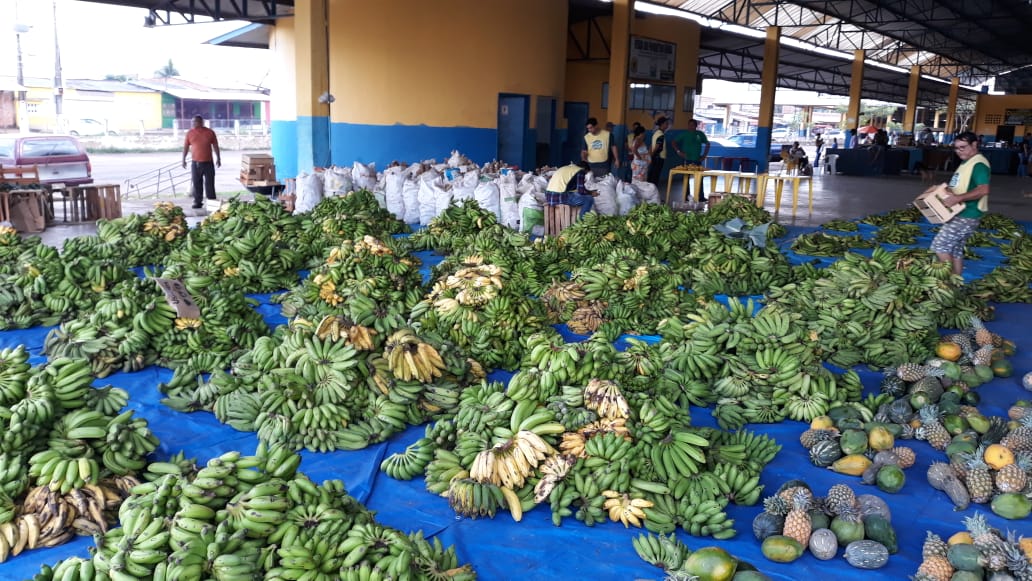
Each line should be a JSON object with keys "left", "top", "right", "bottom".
{"left": 90, "top": 151, "right": 255, "bottom": 198}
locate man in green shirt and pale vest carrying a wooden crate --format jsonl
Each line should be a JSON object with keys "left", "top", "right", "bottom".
{"left": 932, "top": 131, "right": 992, "bottom": 275}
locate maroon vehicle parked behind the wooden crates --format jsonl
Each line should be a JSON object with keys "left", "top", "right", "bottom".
{"left": 0, "top": 134, "right": 93, "bottom": 186}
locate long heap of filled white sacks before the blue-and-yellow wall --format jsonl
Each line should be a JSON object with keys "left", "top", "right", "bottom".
{"left": 294, "top": 152, "right": 659, "bottom": 235}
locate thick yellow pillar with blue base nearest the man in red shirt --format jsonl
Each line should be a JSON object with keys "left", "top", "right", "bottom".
{"left": 294, "top": 0, "right": 330, "bottom": 171}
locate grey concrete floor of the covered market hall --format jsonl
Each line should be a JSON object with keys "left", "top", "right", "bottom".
{"left": 22, "top": 169, "right": 1032, "bottom": 247}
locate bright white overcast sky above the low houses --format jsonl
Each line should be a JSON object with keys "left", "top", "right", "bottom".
{"left": 0, "top": 0, "right": 270, "bottom": 86}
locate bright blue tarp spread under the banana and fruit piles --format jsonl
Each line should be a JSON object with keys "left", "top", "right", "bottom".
{"left": 0, "top": 225, "right": 1032, "bottom": 581}
